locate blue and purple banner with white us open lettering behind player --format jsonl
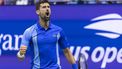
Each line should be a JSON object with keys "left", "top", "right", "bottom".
{"left": 0, "top": 4, "right": 122, "bottom": 69}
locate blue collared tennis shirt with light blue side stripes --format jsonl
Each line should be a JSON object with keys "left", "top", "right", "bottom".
{"left": 21, "top": 23, "right": 68, "bottom": 69}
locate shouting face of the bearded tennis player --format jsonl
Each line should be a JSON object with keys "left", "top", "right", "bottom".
{"left": 37, "top": 3, "right": 51, "bottom": 21}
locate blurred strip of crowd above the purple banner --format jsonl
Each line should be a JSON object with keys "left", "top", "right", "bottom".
{"left": 0, "top": 0, "right": 122, "bottom": 5}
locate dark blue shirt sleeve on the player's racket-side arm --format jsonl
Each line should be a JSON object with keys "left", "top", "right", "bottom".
{"left": 59, "top": 30, "right": 69, "bottom": 49}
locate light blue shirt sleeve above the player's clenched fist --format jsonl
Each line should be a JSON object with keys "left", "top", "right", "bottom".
{"left": 21, "top": 29, "right": 31, "bottom": 46}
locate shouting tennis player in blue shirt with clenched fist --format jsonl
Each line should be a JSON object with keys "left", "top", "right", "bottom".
{"left": 17, "top": 0, "right": 77, "bottom": 69}
